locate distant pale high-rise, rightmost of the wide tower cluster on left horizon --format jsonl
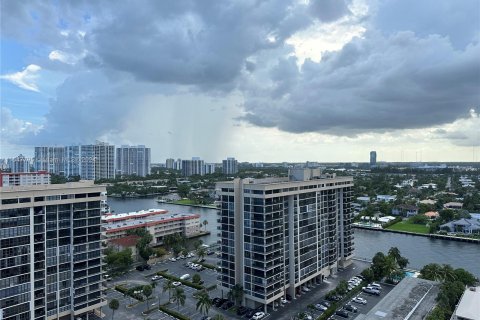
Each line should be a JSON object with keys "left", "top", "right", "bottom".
{"left": 116, "top": 145, "right": 150, "bottom": 177}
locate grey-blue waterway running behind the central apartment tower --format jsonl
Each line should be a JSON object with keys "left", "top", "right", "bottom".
{"left": 108, "top": 198, "right": 480, "bottom": 277}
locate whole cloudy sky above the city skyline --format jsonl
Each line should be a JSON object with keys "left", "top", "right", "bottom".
{"left": 0, "top": 0, "right": 480, "bottom": 162}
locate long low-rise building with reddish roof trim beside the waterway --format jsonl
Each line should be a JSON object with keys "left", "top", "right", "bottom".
{"left": 102, "top": 213, "right": 201, "bottom": 245}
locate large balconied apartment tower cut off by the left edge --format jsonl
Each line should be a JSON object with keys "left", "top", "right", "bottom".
{"left": 0, "top": 181, "right": 106, "bottom": 320}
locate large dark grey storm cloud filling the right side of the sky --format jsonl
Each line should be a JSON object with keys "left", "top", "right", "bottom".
{"left": 244, "top": 32, "right": 480, "bottom": 135}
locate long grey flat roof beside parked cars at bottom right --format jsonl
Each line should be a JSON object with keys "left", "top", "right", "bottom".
{"left": 365, "top": 277, "right": 440, "bottom": 320}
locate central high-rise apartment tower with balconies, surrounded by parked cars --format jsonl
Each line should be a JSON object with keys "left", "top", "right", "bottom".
{"left": 217, "top": 169, "right": 354, "bottom": 310}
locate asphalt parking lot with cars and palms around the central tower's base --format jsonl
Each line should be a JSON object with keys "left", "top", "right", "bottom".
{"left": 102, "top": 255, "right": 380, "bottom": 320}
